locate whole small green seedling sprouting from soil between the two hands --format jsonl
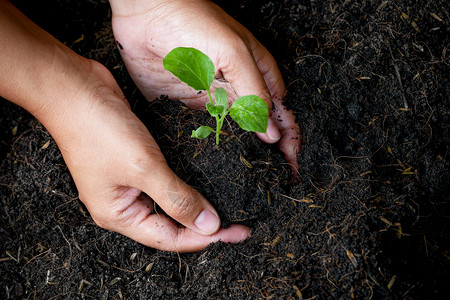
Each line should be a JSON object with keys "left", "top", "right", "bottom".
{"left": 163, "top": 47, "right": 269, "bottom": 145}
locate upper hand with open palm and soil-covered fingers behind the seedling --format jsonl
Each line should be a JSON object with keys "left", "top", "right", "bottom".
{"left": 110, "top": 0, "right": 300, "bottom": 175}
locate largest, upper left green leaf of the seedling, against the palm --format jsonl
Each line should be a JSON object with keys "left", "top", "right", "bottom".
{"left": 163, "top": 47, "right": 215, "bottom": 91}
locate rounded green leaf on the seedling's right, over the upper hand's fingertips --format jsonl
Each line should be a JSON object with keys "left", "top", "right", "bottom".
{"left": 230, "top": 95, "right": 269, "bottom": 133}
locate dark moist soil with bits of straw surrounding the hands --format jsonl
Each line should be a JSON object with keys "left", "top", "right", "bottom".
{"left": 0, "top": 0, "right": 450, "bottom": 299}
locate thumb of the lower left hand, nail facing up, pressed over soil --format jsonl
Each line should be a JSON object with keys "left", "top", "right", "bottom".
{"left": 139, "top": 166, "right": 220, "bottom": 235}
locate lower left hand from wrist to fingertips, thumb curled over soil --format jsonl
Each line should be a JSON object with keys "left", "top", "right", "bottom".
{"left": 46, "top": 61, "right": 249, "bottom": 252}
